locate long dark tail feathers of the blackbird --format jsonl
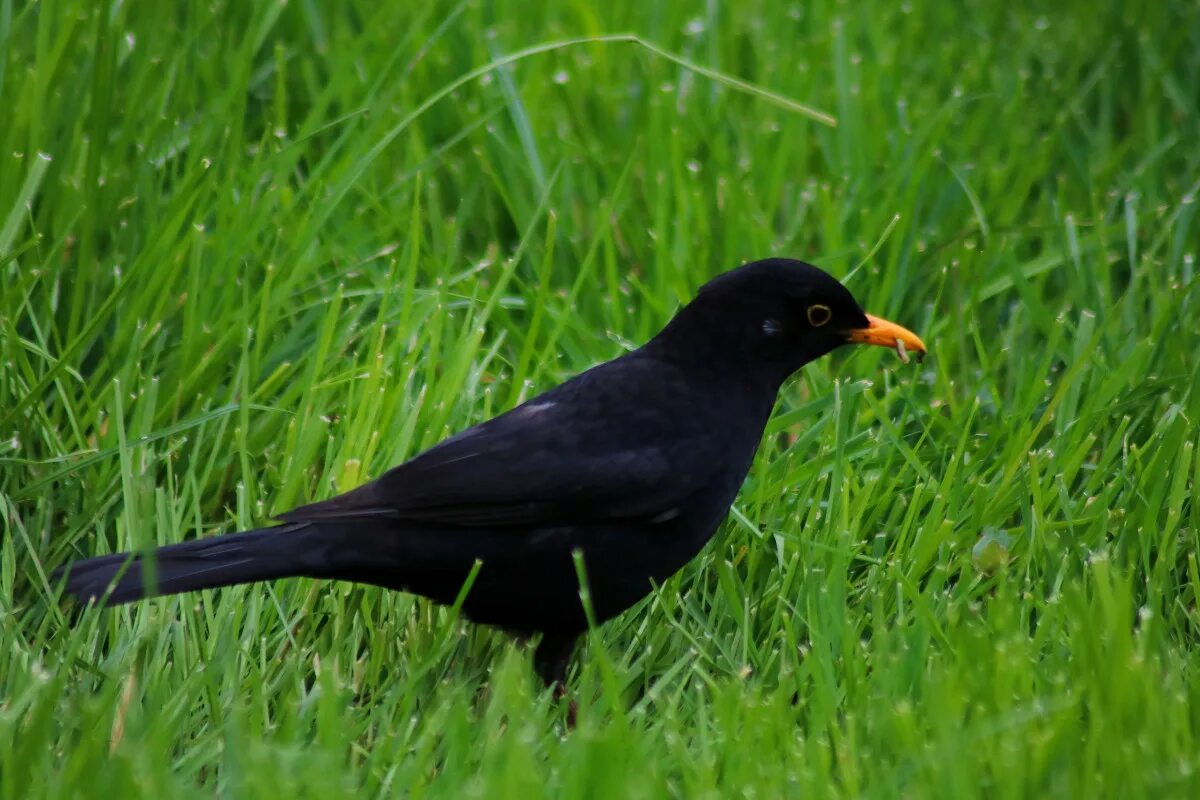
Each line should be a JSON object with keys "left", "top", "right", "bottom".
{"left": 54, "top": 523, "right": 354, "bottom": 606}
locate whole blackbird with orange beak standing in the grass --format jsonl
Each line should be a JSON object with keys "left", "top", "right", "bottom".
{"left": 58, "top": 259, "right": 925, "bottom": 687}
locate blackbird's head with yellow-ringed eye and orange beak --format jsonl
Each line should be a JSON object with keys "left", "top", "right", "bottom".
{"left": 662, "top": 258, "right": 925, "bottom": 381}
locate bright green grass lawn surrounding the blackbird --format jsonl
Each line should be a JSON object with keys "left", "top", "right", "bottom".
{"left": 0, "top": 0, "right": 1200, "bottom": 798}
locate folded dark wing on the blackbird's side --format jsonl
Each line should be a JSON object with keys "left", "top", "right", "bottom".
{"left": 281, "top": 365, "right": 720, "bottom": 527}
